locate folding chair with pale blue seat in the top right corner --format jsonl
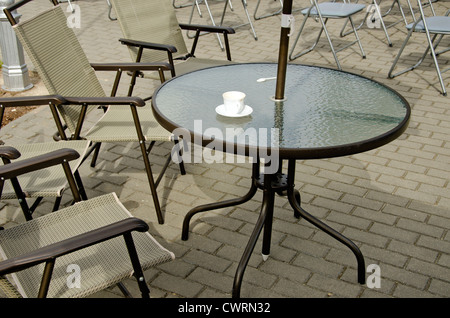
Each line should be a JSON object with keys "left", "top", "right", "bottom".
{"left": 388, "top": 0, "right": 450, "bottom": 96}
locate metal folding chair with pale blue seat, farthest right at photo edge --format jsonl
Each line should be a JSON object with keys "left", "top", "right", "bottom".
{"left": 388, "top": 0, "right": 450, "bottom": 96}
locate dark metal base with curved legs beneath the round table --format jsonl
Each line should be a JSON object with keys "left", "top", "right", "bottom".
{"left": 181, "top": 159, "right": 365, "bottom": 298}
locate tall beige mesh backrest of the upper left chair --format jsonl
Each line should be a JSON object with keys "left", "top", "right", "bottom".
{"left": 13, "top": 6, "right": 106, "bottom": 133}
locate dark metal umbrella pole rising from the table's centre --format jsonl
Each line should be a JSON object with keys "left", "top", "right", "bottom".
{"left": 275, "top": 0, "right": 292, "bottom": 100}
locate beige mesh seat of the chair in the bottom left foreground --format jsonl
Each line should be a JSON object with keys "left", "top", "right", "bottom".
{"left": 0, "top": 193, "right": 174, "bottom": 298}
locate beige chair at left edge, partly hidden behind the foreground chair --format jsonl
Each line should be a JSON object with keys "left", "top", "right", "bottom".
{"left": 0, "top": 96, "right": 90, "bottom": 220}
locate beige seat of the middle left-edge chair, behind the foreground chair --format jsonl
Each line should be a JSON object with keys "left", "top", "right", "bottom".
{"left": 1, "top": 140, "right": 90, "bottom": 200}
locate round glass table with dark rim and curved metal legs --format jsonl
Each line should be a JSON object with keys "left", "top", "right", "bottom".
{"left": 152, "top": 63, "right": 411, "bottom": 297}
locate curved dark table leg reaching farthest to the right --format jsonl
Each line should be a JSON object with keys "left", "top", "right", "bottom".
{"left": 288, "top": 160, "right": 366, "bottom": 284}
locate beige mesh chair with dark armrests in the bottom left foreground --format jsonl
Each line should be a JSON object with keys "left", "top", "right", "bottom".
{"left": 0, "top": 149, "right": 174, "bottom": 298}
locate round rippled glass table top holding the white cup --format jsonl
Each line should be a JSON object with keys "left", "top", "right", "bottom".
{"left": 152, "top": 63, "right": 410, "bottom": 159}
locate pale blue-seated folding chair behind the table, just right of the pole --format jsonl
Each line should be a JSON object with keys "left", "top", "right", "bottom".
{"left": 289, "top": 0, "right": 366, "bottom": 70}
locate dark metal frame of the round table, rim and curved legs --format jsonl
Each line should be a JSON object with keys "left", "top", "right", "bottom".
{"left": 152, "top": 63, "right": 411, "bottom": 298}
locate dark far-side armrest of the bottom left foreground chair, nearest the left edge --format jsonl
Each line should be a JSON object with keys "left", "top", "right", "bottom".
{"left": 0, "top": 147, "right": 80, "bottom": 179}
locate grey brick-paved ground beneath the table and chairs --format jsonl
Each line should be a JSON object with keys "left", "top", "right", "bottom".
{"left": 0, "top": 0, "right": 450, "bottom": 298}
